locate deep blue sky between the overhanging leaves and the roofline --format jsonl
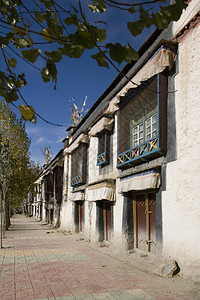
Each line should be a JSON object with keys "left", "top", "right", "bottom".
{"left": 7, "top": 1, "right": 159, "bottom": 164}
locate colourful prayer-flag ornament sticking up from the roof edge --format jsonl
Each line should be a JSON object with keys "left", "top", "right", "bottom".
{"left": 70, "top": 96, "right": 87, "bottom": 125}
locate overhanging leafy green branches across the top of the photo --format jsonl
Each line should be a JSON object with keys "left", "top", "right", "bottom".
{"left": 0, "top": 0, "right": 187, "bottom": 122}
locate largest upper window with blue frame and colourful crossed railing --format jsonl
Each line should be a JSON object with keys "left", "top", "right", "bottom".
{"left": 117, "top": 72, "right": 167, "bottom": 168}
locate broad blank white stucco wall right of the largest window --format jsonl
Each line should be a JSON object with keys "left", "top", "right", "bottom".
{"left": 162, "top": 20, "right": 200, "bottom": 272}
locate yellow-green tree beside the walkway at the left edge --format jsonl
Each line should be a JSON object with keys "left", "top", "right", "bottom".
{"left": 0, "top": 100, "right": 39, "bottom": 229}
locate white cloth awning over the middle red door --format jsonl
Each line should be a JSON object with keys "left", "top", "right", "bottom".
{"left": 85, "top": 181, "right": 115, "bottom": 201}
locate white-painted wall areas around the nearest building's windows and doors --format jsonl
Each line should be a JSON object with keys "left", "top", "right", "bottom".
{"left": 58, "top": 0, "right": 200, "bottom": 274}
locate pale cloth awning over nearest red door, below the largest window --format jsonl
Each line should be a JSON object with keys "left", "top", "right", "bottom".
{"left": 117, "top": 170, "right": 161, "bottom": 193}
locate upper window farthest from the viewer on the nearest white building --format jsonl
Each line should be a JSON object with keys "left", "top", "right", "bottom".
{"left": 71, "top": 143, "right": 87, "bottom": 186}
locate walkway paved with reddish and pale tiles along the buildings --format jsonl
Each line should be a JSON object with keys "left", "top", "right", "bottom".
{"left": 0, "top": 215, "right": 200, "bottom": 300}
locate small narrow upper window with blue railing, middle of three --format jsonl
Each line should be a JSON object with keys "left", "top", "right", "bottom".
{"left": 97, "top": 130, "right": 110, "bottom": 166}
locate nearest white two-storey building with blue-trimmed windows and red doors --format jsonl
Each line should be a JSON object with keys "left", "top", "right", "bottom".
{"left": 34, "top": 0, "right": 200, "bottom": 282}
